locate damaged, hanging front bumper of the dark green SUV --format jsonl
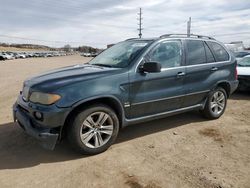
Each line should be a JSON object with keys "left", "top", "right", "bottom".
{"left": 13, "top": 95, "right": 68, "bottom": 150}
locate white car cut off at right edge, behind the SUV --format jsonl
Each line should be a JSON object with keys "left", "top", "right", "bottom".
{"left": 237, "top": 55, "right": 250, "bottom": 91}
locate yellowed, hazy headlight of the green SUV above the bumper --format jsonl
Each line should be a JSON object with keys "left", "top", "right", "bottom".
{"left": 29, "top": 92, "right": 61, "bottom": 105}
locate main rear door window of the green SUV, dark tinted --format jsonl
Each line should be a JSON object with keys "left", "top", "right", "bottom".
{"left": 186, "top": 40, "right": 207, "bottom": 65}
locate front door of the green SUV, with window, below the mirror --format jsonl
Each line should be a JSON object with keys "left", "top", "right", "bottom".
{"left": 129, "top": 40, "right": 185, "bottom": 118}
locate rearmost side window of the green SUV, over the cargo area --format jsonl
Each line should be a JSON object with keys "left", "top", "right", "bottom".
{"left": 207, "top": 41, "right": 229, "bottom": 61}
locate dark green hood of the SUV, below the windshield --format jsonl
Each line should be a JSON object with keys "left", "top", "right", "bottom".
{"left": 24, "top": 64, "right": 118, "bottom": 92}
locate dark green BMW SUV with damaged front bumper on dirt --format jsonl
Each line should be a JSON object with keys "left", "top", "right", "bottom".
{"left": 13, "top": 34, "right": 238, "bottom": 154}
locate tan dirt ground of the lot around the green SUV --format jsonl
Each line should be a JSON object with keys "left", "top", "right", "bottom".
{"left": 0, "top": 56, "right": 250, "bottom": 188}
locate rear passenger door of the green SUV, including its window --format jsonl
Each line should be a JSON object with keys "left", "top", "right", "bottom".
{"left": 183, "top": 39, "right": 217, "bottom": 107}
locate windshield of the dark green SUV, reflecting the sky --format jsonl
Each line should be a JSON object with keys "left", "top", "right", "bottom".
{"left": 89, "top": 41, "right": 149, "bottom": 68}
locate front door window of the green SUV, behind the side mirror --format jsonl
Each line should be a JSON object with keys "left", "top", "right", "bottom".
{"left": 149, "top": 41, "right": 181, "bottom": 68}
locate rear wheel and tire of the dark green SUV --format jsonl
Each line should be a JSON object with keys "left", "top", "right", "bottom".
{"left": 201, "top": 87, "right": 227, "bottom": 119}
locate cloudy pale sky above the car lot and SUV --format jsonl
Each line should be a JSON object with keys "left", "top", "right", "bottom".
{"left": 0, "top": 0, "right": 250, "bottom": 48}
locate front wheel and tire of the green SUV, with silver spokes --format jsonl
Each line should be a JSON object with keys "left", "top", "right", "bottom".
{"left": 67, "top": 104, "right": 119, "bottom": 155}
